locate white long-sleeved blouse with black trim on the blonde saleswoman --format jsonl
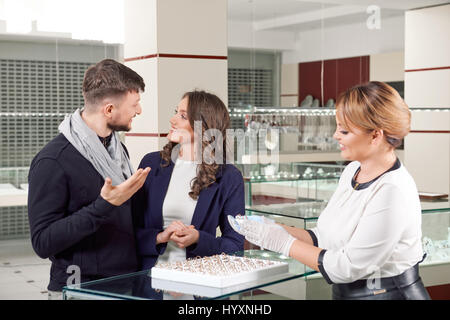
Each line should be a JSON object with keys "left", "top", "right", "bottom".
{"left": 311, "top": 161, "right": 423, "bottom": 283}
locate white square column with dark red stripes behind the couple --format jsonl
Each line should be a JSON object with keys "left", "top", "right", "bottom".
{"left": 124, "top": 0, "right": 228, "bottom": 167}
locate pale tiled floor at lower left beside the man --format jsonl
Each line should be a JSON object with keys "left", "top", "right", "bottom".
{"left": 0, "top": 239, "right": 50, "bottom": 300}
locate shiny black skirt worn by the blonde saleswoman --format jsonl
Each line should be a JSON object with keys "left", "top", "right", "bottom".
{"left": 332, "top": 264, "right": 430, "bottom": 300}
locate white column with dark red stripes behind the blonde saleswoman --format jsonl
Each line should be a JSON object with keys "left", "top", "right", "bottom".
{"left": 405, "top": 5, "right": 450, "bottom": 194}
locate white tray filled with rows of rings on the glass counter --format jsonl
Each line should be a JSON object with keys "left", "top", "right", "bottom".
{"left": 151, "top": 253, "right": 289, "bottom": 288}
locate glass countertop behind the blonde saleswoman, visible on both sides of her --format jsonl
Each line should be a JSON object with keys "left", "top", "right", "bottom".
{"left": 245, "top": 198, "right": 450, "bottom": 221}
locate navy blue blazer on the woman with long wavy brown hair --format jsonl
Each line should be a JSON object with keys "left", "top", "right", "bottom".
{"left": 132, "top": 152, "right": 245, "bottom": 270}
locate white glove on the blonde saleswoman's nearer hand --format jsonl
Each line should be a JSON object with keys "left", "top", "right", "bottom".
{"left": 240, "top": 219, "right": 296, "bottom": 257}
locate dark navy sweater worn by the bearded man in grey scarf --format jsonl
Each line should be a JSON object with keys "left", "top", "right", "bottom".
{"left": 28, "top": 134, "right": 137, "bottom": 291}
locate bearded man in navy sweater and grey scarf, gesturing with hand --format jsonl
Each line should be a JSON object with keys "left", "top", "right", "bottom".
{"left": 28, "top": 59, "right": 150, "bottom": 299}
